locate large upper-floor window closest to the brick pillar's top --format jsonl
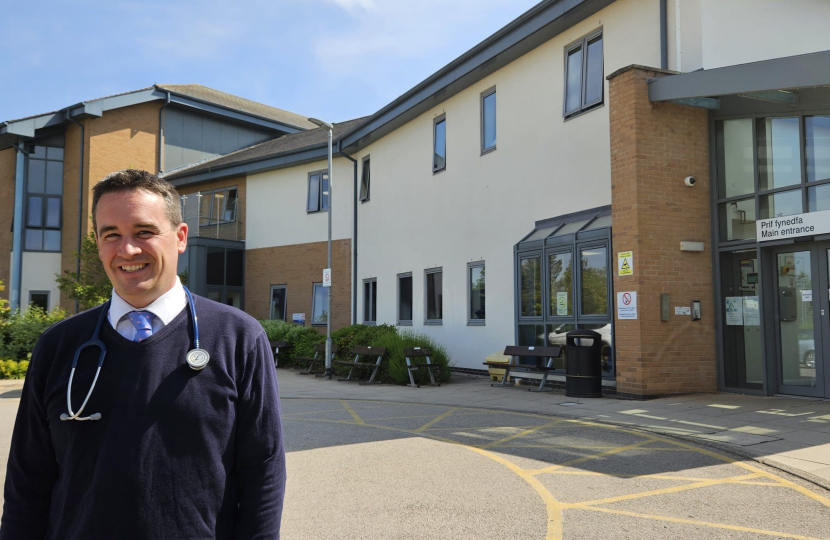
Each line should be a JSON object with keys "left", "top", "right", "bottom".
{"left": 565, "top": 30, "right": 605, "bottom": 118}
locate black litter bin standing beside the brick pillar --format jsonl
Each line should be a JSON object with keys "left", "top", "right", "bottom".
{"left": 565, "top": 329, "right": 602, "bottom": 397}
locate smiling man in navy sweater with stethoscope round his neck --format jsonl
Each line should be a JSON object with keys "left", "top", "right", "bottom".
{"left": 0, "top": 170, "right": 285, "bottom": 540}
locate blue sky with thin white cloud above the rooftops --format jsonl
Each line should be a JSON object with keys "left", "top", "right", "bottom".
{"left": 0, "top": 0, "right": 538, "bottom": 122}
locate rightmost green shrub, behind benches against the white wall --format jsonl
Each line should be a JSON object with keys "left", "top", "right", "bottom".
{"left": 372, "top": 331, "right": 451, "bottom": 385}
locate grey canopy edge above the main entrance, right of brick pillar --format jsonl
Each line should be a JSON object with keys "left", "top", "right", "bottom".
{"left": 648, "top": 51, "right": 830, "bottom": 101}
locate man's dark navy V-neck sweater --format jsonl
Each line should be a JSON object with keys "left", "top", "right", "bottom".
{"left": 0, "top": 297, "right": 285, "bottom": 540}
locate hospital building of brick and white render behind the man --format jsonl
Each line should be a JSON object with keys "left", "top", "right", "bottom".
{"left": 0, "top": 0, "right": 830, "bottom": 399}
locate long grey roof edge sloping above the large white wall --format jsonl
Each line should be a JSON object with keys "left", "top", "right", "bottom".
{"left": 340, "top": 0, "right": 615, "bottom": 150}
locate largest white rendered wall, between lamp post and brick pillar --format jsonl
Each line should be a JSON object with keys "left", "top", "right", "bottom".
{"left": 355, "top": 0, "right": 660, "bottom": 369}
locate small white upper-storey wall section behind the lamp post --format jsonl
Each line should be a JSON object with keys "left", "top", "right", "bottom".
{"left": 245, "top": 158, "right": 354, "bottom": 249}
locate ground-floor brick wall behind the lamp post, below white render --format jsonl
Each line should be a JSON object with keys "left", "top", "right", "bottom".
{"left": 245, "top": 240, "right": 352, "bottom": 333}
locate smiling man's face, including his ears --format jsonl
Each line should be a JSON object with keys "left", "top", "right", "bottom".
{"left": 95, "top": 189, "right": 187, "bottom": 308}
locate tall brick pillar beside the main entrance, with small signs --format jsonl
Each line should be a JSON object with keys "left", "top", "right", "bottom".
{"left": 608, "top": 66, "right": 717, "bottom": 398}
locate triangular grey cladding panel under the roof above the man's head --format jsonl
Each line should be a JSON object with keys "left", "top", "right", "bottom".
{"left": 164, "top": 107, "right": 274, "bottom": 171}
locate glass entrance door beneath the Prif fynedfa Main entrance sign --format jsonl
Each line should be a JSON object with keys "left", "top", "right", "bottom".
{"left": 773, "top": 243, "right": 830, "bottom": 397}
